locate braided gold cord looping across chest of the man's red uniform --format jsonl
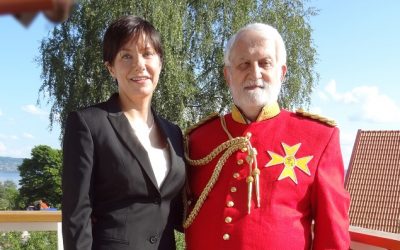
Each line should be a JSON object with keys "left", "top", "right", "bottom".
{"left": 183, "top": 137, "right": 249, "bottom": 229}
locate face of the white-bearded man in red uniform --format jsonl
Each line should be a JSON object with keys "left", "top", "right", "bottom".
{"left": 224, "top": 30, "right": 286, "bottom": 110}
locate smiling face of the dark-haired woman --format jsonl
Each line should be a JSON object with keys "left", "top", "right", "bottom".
{"left": 107, "top": 35, "right": 162, "bottom": 101}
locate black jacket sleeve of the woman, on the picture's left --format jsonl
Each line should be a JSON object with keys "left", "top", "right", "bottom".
{"left": 62, "top": 112, "right": 94, "bottom": 250}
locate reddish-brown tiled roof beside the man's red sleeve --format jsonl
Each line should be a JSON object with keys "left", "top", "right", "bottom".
{"left": 345, "top": 130, "right": 400, "bottom": 233}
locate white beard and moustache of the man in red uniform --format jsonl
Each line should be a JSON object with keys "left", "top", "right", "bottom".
{"left": 229, "top": 80, "right": 281, "bottom": 109}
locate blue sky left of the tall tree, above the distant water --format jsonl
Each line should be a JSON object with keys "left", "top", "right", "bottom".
{"left": 0, "top": 15, "right": 60, "bottom": 157}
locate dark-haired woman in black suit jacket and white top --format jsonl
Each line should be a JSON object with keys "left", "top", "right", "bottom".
{"left": 62, "top": 16, "right": 185, "bottom": 250}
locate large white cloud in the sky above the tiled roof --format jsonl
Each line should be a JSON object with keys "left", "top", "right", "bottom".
{"left": 324, "top": 80, "right": 400, "bottom": 123}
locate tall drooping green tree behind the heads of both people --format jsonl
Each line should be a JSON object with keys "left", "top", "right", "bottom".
{"left": 37, "top": 0, "right": 318, "bottom": 132}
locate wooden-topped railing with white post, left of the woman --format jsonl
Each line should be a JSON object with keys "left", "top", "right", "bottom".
{"left": 0, "top": 211, "right": 63, "bottom": 250}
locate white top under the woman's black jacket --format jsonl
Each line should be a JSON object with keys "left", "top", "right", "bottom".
{"left": 133, "top": 119, "right": 171, "bottom": 188}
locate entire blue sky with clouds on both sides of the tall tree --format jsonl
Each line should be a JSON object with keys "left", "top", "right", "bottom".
{"left": 0, "top": 0, "right": 400, "bottom": 170}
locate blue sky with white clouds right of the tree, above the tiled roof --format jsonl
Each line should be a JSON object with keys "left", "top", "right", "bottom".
{"left": 310, "top": 0, "right": 400, "bottom": 168}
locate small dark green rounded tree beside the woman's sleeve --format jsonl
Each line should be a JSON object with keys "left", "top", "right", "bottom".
{"left": 18, "top": 145, "right": 62, "bottom": 208}
